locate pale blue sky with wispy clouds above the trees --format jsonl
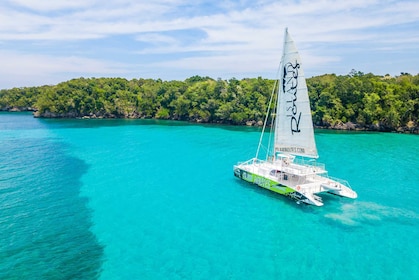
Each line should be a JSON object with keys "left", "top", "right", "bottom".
{"left": 0, "top": 0, "right": 419, "bottom": 88}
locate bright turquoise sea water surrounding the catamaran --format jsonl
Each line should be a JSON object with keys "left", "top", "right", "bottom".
{"left": 0, "top": 113, "right": 419, "bottom": 279}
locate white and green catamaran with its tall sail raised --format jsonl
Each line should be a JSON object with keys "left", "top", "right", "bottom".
{"left": 233, "top": 29, "right": 357, "bottom": 206}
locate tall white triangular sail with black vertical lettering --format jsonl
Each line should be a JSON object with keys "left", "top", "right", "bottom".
{"left": 275, "top": 29, "right": 318, "bottom": 158}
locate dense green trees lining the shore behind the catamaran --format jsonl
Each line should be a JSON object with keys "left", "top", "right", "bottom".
{"left": 0, "top": 70, "right": 419, "bottom": 132}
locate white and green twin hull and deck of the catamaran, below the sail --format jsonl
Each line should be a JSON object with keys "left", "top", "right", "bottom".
{"left": 234, "top": 157, "right": 357, "bottom": 206}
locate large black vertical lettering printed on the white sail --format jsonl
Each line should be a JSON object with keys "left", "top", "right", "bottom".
{"left": 282, "top": 61, "right": 301, "bottom": 134}
